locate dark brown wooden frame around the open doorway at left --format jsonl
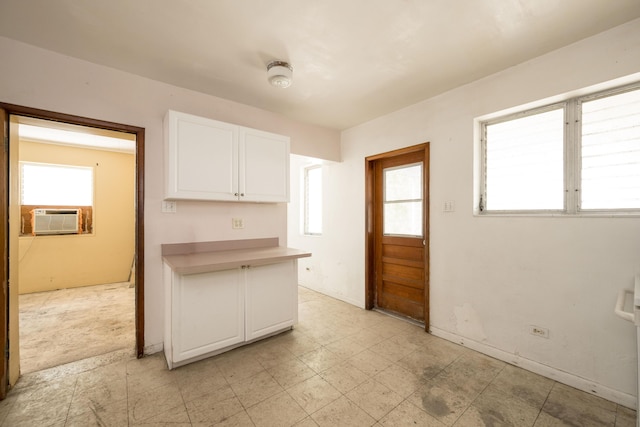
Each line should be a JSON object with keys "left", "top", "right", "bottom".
{"left": 0, "top": 102, "right": 145, "bottom": 399}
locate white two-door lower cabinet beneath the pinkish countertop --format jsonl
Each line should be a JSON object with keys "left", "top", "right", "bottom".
{"left": 164, "top": 260, "right": 298, "bottom": 369}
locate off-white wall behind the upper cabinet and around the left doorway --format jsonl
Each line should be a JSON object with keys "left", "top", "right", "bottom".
{"left": 0, "top": 37, "right": 340, "bottom": 352}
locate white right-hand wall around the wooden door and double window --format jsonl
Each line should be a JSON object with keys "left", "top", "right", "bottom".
{"left": 308, "top": 20, "right": 640, "bottom": 406}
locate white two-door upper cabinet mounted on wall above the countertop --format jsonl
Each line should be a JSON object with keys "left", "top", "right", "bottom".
{"left": 164, "top": 111, "right": 289, "bottom": 202}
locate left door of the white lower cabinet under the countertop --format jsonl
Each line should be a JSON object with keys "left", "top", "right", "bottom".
{"left": 172, "top": 269, "right": 245, "bottom": 362}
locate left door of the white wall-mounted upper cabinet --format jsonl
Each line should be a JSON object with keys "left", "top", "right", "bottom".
{"left": 165, "top": 111, "right": 238, "bottom": 200}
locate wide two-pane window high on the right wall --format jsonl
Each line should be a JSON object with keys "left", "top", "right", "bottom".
{"left": 480, "top": 85, "right": 640, "bottom": 214}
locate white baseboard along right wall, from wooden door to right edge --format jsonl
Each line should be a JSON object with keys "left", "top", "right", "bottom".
{"left": 429, "top": 327, "right": 637, "bottom": 409}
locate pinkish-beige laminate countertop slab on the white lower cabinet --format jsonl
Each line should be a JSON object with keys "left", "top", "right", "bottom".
{"left": 162, "top": 246, "right": 311, "bottom": 274}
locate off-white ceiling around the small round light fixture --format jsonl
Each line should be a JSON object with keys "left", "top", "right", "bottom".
{"left": 0, "top": 0, "right": 640, "bottom": 129}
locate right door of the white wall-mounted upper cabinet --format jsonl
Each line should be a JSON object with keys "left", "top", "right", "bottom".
{"left": 239, "top": 128, "right": 289, "bottom": 202}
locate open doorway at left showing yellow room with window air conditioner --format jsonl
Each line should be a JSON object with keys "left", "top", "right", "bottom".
{"left": 0, "top": 104, "right": 144, "bottom": 392}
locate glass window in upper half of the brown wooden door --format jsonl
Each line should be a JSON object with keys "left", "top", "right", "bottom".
{"left": 382, "top": 163, "right": 423, "bottom": 237}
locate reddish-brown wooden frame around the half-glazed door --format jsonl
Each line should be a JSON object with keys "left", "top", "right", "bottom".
{"left": 364, "top": 142, "right": 430, "bottom": 332}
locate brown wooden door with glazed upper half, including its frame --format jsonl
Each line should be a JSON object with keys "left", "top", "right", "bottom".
{"left": 366, "top": 144, "right": 429, "bottom": 328}
